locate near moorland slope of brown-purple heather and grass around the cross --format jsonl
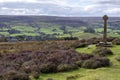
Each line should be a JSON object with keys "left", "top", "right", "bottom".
{"left": 0, "top": 38, "right": 120, "bottom": 80}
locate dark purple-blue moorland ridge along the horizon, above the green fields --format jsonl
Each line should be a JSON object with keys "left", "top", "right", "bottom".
{"left": 0, "top": 15, "right": 120, "bottom": 27}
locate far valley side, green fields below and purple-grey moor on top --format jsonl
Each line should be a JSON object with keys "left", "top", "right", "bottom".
{"left": 0, "top": 15, "right": 120, "bottom": 41}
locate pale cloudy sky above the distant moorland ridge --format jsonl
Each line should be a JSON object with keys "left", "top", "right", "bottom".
{"left": 0, "top": 0, "right": 120, "bottom": 17}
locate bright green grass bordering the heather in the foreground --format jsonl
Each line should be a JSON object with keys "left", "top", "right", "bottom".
{"left": 33, "top": 45, "right": 120, "bottom": 80}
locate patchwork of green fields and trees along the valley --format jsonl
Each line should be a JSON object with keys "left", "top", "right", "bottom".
{"left": 0, "top": 23, "right": 120, "bottom": 39}
